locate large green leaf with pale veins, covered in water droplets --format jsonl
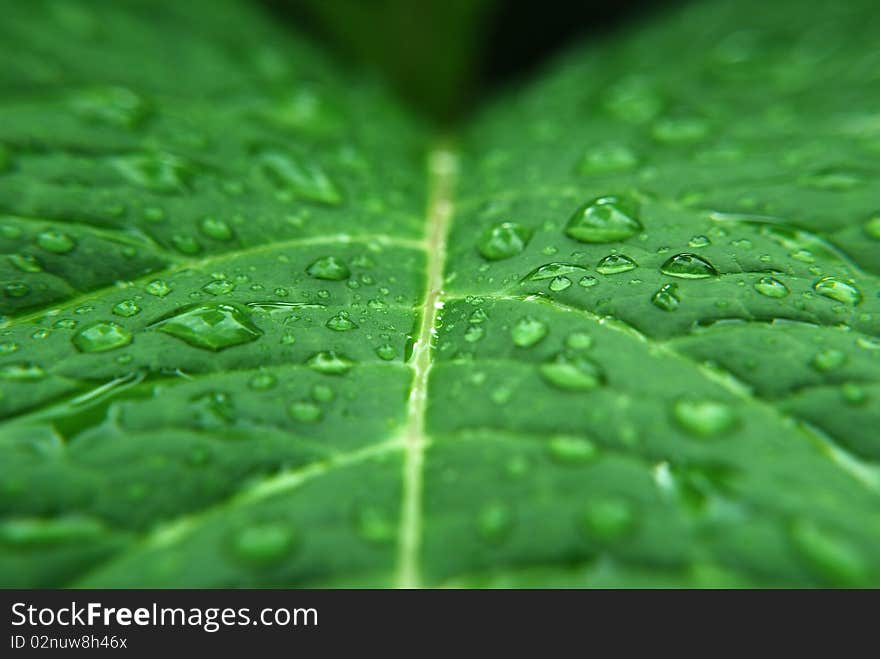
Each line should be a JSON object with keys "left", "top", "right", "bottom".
{"left": 0, "top": 0, "right": 880, "bottom": 587}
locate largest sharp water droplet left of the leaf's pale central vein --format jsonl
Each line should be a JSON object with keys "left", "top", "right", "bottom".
{"left": 155, "top": 302, "right": 262, "bottom": 351}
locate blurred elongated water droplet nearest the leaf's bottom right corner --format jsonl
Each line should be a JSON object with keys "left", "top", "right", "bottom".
{"left": 791, "top": 520, "right": 870, "bottom": 587}
